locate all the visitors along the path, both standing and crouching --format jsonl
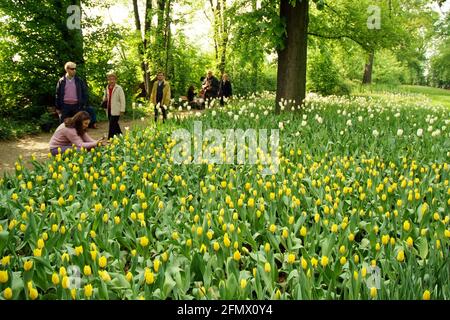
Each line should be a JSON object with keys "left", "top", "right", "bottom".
{"left": 49, "top": 62, "right": 232, "bottom": 155}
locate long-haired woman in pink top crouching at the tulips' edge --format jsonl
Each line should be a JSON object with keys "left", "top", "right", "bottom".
{"left": 50, "top": 111, "right": 105, "bottom": 155}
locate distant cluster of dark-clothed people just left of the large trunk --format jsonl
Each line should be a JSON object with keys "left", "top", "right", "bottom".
{"left": 187, "top": 70, "right": 233, "bottom": 108}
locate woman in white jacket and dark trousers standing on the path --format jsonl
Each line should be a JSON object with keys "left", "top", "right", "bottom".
{"left": 103, "top": 73, "right": 126, "bottom": 139}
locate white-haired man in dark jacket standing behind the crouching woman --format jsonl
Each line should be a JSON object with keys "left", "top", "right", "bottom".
{"left": 55, "top": 61, "right": 88, "bottom": 123}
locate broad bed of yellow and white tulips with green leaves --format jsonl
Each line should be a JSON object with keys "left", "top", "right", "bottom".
{"left": 0, "top": 94, "right": 450, "bottom": 300}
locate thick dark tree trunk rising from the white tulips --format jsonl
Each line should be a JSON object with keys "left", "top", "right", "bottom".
{"left": 275, "top": 0, "right": 309, "bottom": 113}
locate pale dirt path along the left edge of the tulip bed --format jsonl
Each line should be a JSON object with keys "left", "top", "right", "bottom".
{"left": 0, "top": 111, "right": 202, "bottom": 177}
